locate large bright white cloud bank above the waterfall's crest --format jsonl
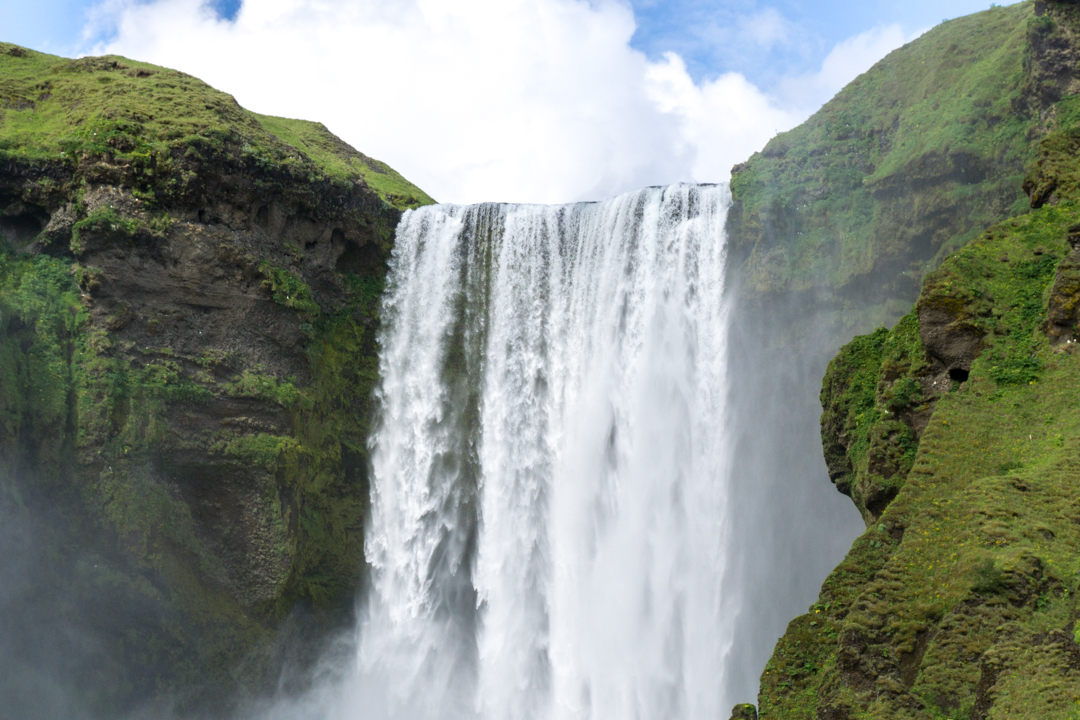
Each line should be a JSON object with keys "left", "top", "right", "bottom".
{"left": 87, "top": 0, "right": 909, "bottom": 203}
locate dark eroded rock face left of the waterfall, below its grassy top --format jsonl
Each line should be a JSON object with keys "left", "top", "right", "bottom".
{"left": 0, "top": 118, "right": 408, "bottom": 717}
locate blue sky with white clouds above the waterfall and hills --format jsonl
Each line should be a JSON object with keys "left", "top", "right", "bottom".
{"left": 0, "top": 0, "right": 1009, "bottom": 203}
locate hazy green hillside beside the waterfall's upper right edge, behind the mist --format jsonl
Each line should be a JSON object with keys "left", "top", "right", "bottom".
{"left": 729, "top": 2, "right": 1036, "bottom": 331}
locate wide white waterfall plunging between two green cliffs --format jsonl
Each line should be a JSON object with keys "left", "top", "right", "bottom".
{"left": 357, "top": 185, "right": 737, "bottom": 720}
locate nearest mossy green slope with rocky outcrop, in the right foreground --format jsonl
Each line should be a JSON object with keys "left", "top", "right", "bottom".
{"left": 759, "top": 26, "right": 1080, "bottom": 719}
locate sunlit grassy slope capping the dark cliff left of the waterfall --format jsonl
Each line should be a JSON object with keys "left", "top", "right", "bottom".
{"left": 0, "top": 43, "right": 434, "bottom": 209}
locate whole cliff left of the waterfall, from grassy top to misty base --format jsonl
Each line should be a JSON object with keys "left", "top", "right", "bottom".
{"left": 0, "top": 43, "right": 433, "bottom": 717}
